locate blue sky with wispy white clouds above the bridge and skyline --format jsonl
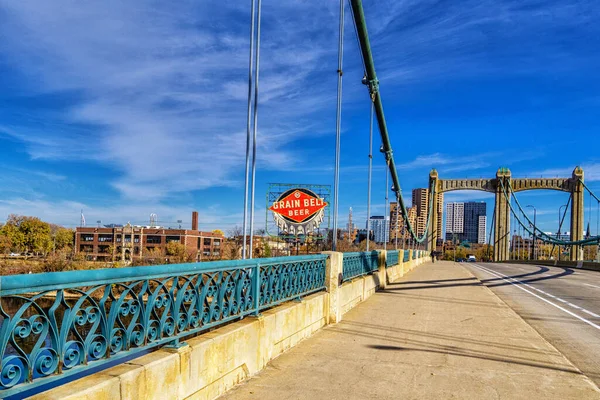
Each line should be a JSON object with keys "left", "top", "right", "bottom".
{"left": 0, "top": 0, "right": 600, "bottom": 236}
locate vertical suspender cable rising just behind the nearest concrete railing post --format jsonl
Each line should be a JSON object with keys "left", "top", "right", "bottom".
{"left": 331, "top": 0, "right": 344, "bottom": 251}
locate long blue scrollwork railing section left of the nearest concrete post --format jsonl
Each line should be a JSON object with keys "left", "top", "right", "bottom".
{"left": 0, "top": 255, "right": 327, "bottom": 397}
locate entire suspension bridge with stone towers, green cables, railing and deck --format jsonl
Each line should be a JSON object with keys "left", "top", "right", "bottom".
{"left": 0, "top": 0, "right": 600, "bottom": 399}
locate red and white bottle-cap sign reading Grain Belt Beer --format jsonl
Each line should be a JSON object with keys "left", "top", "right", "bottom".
{"left": 269, "top": 188, "right": 327, "bottom": 235}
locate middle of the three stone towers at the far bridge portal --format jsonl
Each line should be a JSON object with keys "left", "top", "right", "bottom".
{"left": 494, "top": 168, "right": 511, "bottom": 261}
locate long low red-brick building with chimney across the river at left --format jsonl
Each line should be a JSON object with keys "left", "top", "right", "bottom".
{"left": 75, "top": 211, "right": 224, "bottom": 261}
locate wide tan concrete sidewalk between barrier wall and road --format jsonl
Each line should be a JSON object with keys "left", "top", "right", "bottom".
{"left": 221, "top": 262, "right": 600, "bottom": 400}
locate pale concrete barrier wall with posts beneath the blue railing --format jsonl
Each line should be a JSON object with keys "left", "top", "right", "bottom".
{"left": 30, "top": 252, "right": 426, "bottom": 400}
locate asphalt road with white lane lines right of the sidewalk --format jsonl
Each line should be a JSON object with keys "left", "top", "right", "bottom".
{"left": 462, "top": 263, "right": 600, "bottom": 386}
